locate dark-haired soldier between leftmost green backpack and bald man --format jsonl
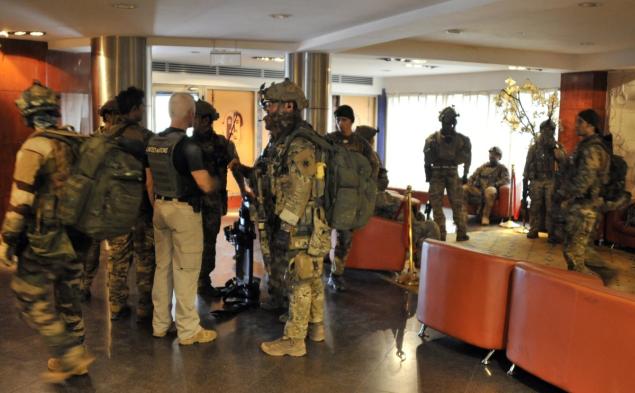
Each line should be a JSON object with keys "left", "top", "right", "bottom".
{"left": 105, "top": 87, "right": 156, "bottom": 321}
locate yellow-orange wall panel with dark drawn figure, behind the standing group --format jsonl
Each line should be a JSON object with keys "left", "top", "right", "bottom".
{"left": 206, "top": 89, "right": 256, "bottom": 195}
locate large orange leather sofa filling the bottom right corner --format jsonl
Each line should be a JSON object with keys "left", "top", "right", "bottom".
{"left": 507, "top": 263, "right": 635, "bottom": 393}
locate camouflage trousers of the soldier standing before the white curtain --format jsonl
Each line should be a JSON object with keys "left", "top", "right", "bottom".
{"left": 428, "top": 168, "right": 467, "bottom": 239}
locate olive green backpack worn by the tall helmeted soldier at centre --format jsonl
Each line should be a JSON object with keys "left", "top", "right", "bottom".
{"left": 284, "top": 128, "right": 377, "bottom": 230}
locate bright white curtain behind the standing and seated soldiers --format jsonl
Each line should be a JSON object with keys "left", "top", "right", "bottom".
{"left": 386, "top": 92, "right": 557, "bottom": 191}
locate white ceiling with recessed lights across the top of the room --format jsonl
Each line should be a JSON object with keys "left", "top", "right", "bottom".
{"left": 0, "top": 0, "right": 635, "bottom": 77}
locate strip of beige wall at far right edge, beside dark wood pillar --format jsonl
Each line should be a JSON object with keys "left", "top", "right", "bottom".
{"left": 608, "top": 71, "right": 635, "bottom": 195}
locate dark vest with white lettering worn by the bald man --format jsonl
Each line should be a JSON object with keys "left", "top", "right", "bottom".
{"left": 146, "top": 131, "right": 197, "bottom": 198}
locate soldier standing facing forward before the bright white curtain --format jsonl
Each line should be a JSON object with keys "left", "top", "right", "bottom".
{"left": 423, "top": 107, "right": 472, "bottom": 241}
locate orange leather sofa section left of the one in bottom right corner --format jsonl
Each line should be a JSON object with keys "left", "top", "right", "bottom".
{"left": 417, "top": 240, "right": 516, "bottom": 354}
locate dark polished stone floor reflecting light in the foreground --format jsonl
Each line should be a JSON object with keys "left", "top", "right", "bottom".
{"left": 0, "top": 214, "right": 559, "bottom": 393}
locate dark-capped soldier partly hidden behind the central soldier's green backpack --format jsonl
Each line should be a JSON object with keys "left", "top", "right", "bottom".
{"left": 326, "top": 105, "right": 380, "bottom": 291}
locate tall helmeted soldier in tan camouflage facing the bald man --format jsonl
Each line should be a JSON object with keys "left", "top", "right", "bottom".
{"left": 260, "top": 79, "right": 331, "bottom": 356}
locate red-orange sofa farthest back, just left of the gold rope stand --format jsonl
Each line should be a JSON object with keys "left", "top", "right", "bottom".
{"left": 346, "top": 216, "right": 406, "bottom": 272}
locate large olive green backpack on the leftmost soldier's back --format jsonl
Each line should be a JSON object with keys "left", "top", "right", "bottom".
{"left": 57, "top": 125, "right": 145, "bottom": 240}
